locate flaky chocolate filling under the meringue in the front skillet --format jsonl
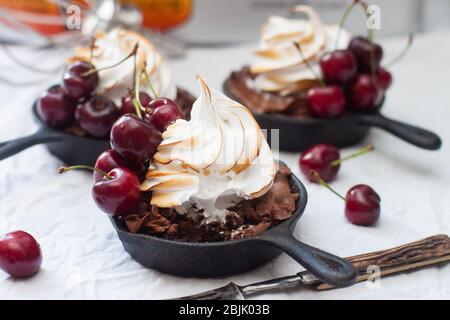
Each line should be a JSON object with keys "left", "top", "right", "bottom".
{"left": 125, "top": 166, "right": 299, "bottom": 242}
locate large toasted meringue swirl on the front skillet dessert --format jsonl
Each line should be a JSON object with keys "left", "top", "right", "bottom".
{"left": 141, "top": 76, "right": 276, "bottom": 223}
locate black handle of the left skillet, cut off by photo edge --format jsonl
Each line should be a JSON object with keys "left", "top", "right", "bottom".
{"left": 0, "top": 129, "right": 63, "bottom": 160}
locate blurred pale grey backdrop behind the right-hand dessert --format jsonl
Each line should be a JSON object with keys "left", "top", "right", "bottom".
{"left": 176, "top": 0, "right": 450, "bottom": 43}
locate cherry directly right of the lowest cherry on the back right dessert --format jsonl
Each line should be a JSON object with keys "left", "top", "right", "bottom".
{"left": 347, "top": 74, "right": 384, "bottom": 112}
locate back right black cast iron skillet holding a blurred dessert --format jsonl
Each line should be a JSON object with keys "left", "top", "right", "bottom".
{"left": 223, "top": 81, "right": 441, "bottom": 151}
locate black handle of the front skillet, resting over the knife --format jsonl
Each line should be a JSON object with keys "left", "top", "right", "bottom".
{"left": 261, "top": 234, "right": 357, "bottom": 287}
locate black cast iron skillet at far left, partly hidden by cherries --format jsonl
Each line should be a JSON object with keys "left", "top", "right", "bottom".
{"left": 0, "top": 103, "right": 110, "bottom": 165}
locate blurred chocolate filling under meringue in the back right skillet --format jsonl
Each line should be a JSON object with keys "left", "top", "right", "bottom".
{"left": 225, "top": 67, "right": 311, "bottom": 118}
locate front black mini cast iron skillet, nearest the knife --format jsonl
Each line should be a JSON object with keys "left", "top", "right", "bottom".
{"left": 110, "top": 168, "right": 356, "bottom": 286}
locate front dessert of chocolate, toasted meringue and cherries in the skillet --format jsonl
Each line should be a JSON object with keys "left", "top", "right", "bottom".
{"left": 60, "top": 76, "right": 298, "bottom": 242}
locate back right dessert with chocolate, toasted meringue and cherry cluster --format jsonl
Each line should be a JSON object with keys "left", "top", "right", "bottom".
{"left": 225, "top": 2, "right": 400, "bottom": 118}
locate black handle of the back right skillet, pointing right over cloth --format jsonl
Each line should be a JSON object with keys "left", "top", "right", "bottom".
{"left": 358, "top": 113, "right": 442, "bottom": 150}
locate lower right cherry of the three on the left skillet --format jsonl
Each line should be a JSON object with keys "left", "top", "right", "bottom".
{"left": 75, "top": 96, "right": 119, "bottom": 138}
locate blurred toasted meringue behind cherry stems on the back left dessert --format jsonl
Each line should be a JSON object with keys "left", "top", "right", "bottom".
{"left": 75, "top": 28, "right": 177, "bottom": 105}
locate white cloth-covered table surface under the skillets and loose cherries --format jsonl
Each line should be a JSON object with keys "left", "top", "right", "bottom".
{"left": 0, "top": 32, "right": 450, "bottom": 299}
